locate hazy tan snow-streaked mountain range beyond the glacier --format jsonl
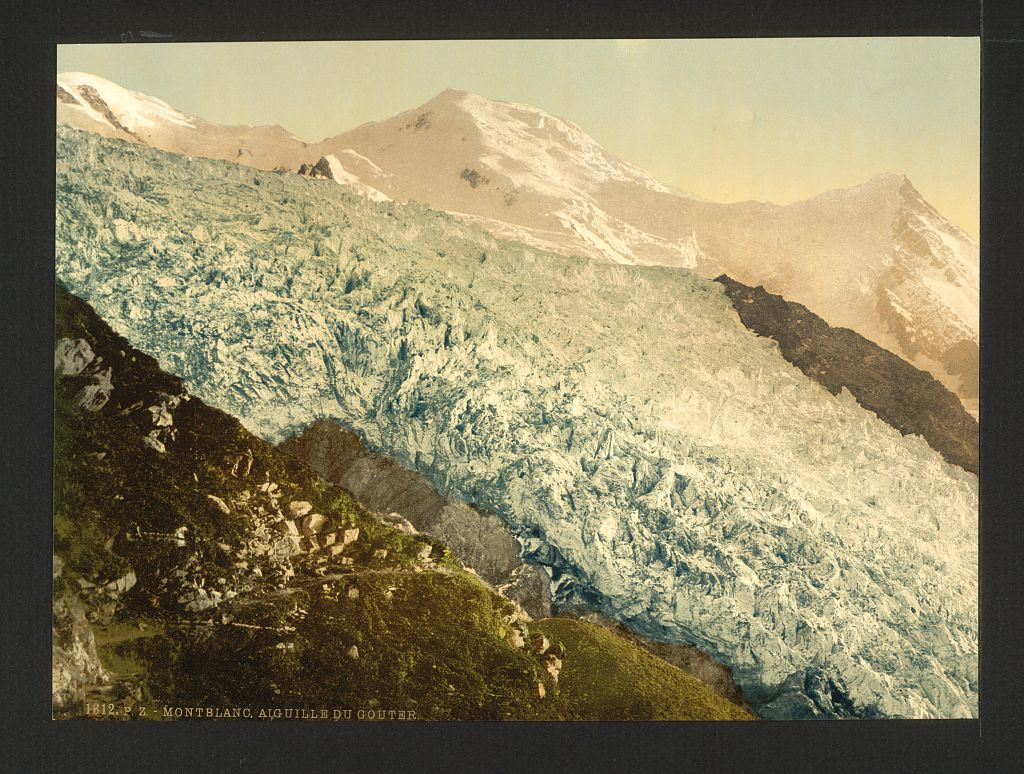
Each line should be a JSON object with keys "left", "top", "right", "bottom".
{"left": 57, "top": 74, "right": 979, "bottom": 416}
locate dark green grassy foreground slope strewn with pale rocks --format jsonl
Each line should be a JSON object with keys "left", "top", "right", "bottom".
{"left": 53, "top": 288, "right": 750, "bottom": 720}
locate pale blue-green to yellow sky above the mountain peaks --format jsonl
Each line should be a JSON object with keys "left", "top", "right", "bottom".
{"left": 57, "top": 38, "right": 980, "bottom": 238}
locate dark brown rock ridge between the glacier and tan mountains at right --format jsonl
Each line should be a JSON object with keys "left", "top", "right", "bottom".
{"left": 716, "top": 274, "right": 978, "bottom": 474}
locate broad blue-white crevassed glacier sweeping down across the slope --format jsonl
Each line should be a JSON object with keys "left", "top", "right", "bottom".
{"left": 55, "top": 128, "right": 978, "bottom": 718}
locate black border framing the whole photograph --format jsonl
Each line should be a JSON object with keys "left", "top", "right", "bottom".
{"left": 0, "top": 0, "right": 1024, "bottom": 772}
